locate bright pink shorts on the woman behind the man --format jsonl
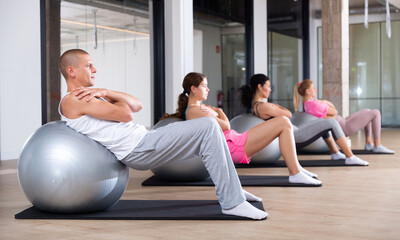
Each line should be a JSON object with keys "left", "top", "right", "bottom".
{"left": 224, "top": 129, "right": 250, "bottom": 164}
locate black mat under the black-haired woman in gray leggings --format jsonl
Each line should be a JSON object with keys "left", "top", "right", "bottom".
{"left": 235, "top": 159, "right": 365, "bottom": 168}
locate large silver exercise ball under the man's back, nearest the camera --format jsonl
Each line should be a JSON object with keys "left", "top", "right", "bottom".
{"left": 18, "top": 121, "right": 129, "bottom": 213}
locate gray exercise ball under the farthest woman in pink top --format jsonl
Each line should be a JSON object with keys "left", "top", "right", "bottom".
{"left": 290, "top": 112, "right": 329, "bottom": 153}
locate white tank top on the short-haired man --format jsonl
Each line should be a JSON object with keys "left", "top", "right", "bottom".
{"left": 58, "top": 93, "right": 148, "bottom": 160}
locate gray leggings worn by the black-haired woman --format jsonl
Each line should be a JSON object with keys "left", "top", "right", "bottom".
{"left": 293, "top": 118, "right": 344, "bottom": 149}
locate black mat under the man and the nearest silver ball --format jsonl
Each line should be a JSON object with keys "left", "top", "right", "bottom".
{"left": 15, "top": 200, "right": 264, "bottom": 220}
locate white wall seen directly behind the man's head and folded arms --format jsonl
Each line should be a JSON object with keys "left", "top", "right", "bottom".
{"left": 61, "top": 37, "right": 153, "bottom": 128}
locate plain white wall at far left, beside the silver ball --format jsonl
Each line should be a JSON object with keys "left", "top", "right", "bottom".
{"left": 0, "top": 0, "right": 41, "bottom": 160}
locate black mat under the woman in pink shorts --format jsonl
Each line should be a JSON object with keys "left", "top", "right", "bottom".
{"left": 142, "top": 175, "right": 322, "bottom": 187}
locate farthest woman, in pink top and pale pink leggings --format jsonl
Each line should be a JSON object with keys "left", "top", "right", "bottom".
{"left": 293, "top": 79, "right": 394, "bottom": 153}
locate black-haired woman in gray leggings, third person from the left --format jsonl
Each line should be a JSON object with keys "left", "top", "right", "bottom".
{"left": 240, "top": 74, "right": 369, "bottom": 165}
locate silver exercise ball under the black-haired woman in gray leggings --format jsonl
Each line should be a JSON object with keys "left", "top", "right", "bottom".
{"left": 230, "top": 113, "right": 281, "bottom": 164}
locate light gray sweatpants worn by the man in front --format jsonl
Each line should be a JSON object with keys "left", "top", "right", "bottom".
{"left": 121, "top": 117, "right": 245, "bottom": 209}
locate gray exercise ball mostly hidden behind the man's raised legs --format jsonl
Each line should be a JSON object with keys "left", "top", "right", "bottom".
{"left": 151, "top": 118, "right": 210, "bottom": 182}
